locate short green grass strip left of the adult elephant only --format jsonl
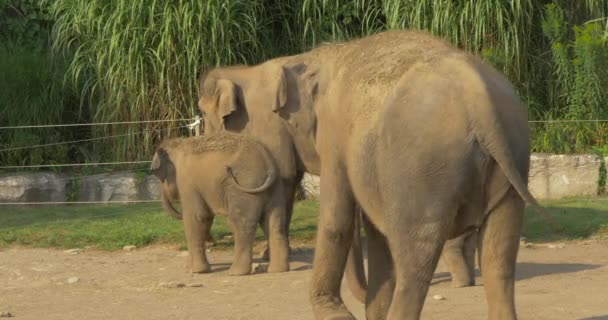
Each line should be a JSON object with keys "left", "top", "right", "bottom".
{"left": 0, "top": 201, "right": 318, "bottom": 250}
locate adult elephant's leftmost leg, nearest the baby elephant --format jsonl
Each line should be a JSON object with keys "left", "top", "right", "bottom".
{"left": 310, "top": 162, "right": 355, "bottom": 320}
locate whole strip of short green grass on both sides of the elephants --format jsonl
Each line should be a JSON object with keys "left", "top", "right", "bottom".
{"left": 0, "top": 198, "right": 608, "bottom": 250}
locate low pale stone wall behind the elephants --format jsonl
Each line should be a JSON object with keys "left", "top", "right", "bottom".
{"left": 0, "top": 154, "right": 608, "bottom": 203}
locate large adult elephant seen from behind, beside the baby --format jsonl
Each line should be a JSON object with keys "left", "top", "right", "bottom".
{"left": 199, "top": 31, "right": 536, "bottom": 319}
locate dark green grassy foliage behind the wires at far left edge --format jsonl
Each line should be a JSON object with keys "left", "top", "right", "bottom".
{"left": 0, "top": 46, "right": 78, "bottom": 171}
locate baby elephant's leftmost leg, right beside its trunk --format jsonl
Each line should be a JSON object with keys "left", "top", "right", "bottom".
{"left": 181, "top": 192, "right": 213, "bottom": 273}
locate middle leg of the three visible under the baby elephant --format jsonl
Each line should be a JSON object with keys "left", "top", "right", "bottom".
{"left": 228, "top": 208, "right": 260, "bottom": 276}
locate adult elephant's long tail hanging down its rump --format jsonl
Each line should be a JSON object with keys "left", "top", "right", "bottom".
{"left": 467, "top": 61, "right": 557, "bottom": 227}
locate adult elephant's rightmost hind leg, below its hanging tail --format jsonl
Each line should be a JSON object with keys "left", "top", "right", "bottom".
{"left": 479, "top": 188, "right": 524, "bottom": 320}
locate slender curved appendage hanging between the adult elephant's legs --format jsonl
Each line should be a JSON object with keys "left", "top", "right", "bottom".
{"left": 345, "top": 208, "right": 367, "bottom": 303}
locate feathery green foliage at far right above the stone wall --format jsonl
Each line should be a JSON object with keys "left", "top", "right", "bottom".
{"left": 533, "top": 4, "right": 608, "bottom": 153}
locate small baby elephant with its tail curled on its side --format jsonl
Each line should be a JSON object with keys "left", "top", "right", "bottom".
{"left": 150, "top": 133, "right": 289, "bottom": 275}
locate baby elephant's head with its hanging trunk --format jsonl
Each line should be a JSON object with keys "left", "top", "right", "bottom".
{"left": 150, "top": 147, "right": 182, "bottom": 220}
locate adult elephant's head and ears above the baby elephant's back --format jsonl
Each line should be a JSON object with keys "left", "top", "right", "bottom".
{"left": 198, "top": 60, "right": 319, "bottom": 174}
